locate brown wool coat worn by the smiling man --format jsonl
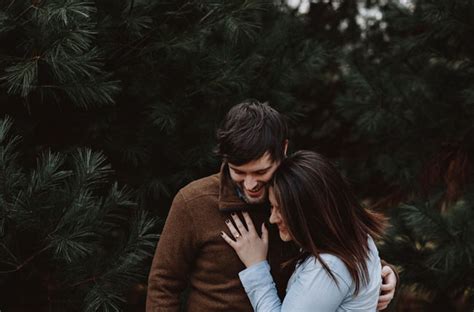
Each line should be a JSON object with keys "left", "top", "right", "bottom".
{"left": 146, "top": 164, "right": 292, "bottom": 312}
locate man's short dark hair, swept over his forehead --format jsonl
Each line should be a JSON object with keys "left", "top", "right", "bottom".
{"left": 216, "top": 100, "right": 288, "bottom": 166}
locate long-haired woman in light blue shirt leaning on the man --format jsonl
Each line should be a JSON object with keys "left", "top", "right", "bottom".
{"left": 221, "top": 151, "right": 383, "bottom": 312}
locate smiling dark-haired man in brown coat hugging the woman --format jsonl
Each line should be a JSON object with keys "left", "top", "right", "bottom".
{"left": 147, "top": 101, "right": 396, "bottom": 312}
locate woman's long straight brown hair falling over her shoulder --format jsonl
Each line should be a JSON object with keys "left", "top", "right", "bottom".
{"left": 272, "top": 151, "right": 385, "bottom": 294}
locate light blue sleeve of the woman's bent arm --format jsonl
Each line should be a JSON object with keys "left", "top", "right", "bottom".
{"left": 239, "top": 258, "right": 350, "bottom": 312}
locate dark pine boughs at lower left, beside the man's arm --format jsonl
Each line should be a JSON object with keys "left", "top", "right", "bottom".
{"left": 0, "top": 118, "right": 157, "bottom": 311}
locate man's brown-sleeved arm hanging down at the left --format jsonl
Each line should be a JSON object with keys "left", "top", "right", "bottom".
{"left": 146, "top": 193, "right": 196, "bottom": 312}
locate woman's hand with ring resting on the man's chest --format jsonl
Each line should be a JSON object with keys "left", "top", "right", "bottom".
{"left": 221, "top": 212, "right": 268, "bottom": 267}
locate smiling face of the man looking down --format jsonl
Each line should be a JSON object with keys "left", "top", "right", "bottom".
{"left": 229, "top": 152, "right": 280, "bottom": 204}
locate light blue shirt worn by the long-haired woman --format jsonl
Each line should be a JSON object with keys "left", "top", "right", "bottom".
{"left": 239, "top": 237, "right": 382, "bottom": 312}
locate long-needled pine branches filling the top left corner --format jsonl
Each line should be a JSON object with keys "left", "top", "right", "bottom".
{"left": 0, "top": 0, "right": 119, "bottom": 108}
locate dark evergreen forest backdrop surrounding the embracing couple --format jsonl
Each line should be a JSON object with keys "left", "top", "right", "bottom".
{"left": 0, "top": 0, "right": 474, "bottom": 312}
